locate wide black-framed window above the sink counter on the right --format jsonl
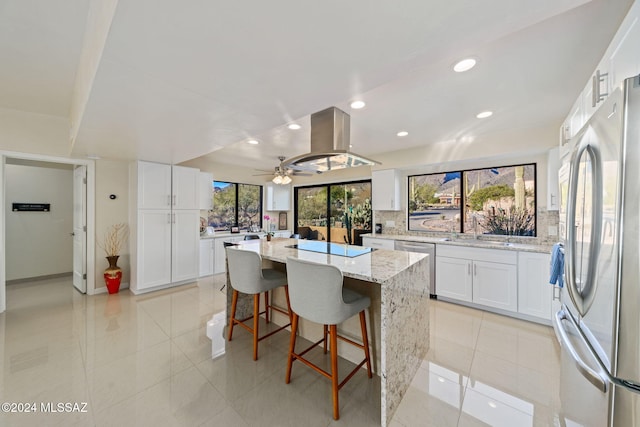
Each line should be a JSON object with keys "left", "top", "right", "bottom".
{"left": 408, "top": 164, "right": 536, "bottom": 236}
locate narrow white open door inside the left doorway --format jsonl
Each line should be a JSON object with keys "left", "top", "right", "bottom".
{"left": 73, "top": 166, "right": 87, "bottom": 294}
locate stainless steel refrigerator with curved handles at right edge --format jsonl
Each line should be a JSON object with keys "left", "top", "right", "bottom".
{"left": 554, "top": 76, "right": 640, "bottom": 427}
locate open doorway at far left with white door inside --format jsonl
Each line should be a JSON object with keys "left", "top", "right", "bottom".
{"left": 0, "top": 153, "right": 95, "bottom": 312}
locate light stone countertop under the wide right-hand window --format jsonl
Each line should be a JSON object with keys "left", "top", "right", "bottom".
{"left": 362, "top": 233, "right": 551, "bottom": 254}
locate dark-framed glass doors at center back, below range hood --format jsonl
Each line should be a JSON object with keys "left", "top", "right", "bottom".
{"left": 295, "top": 181, "right": 371, "bottom": 244}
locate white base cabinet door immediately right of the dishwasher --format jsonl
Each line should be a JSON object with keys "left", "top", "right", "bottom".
{"left": 436, "top": 255, "right": 473, "bottom": 302}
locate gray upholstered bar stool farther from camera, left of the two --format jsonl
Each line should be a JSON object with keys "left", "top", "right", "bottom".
{"left": 226, "top": 247, "right": 291, "bottom": 360}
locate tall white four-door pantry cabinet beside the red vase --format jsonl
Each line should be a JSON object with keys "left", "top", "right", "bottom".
{"left": 130, "top": 162, "right": 200, "bottom": 293}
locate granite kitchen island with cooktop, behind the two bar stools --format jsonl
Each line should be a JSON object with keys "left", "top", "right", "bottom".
{"left": 227, "top": 239, "right": 429, "bottom": 426}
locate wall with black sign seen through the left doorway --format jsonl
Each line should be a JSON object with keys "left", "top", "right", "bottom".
{"left": 5, "top": 164, "right": 73, "bottom": 280}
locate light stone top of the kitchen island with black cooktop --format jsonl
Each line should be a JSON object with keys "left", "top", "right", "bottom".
{"left": 228, "top": 238, "right": 428, "bottom": 284}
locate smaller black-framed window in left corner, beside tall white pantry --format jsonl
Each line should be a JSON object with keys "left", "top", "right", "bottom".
{"left": 208, "top": 181, "right": 262, "bottom": 231}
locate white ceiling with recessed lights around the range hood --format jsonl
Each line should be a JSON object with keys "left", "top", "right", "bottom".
{"left": 0, "top": 0, "right": 631, "bottom": 168}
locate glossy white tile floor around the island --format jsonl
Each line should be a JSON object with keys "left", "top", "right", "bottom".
{"left": 0, "top": 275, "right": 559, "bottom": 427}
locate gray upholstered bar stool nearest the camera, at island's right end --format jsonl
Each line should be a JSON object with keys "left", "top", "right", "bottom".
{"left": 285, "top": 257, "right": 371, "bottom": 420}
